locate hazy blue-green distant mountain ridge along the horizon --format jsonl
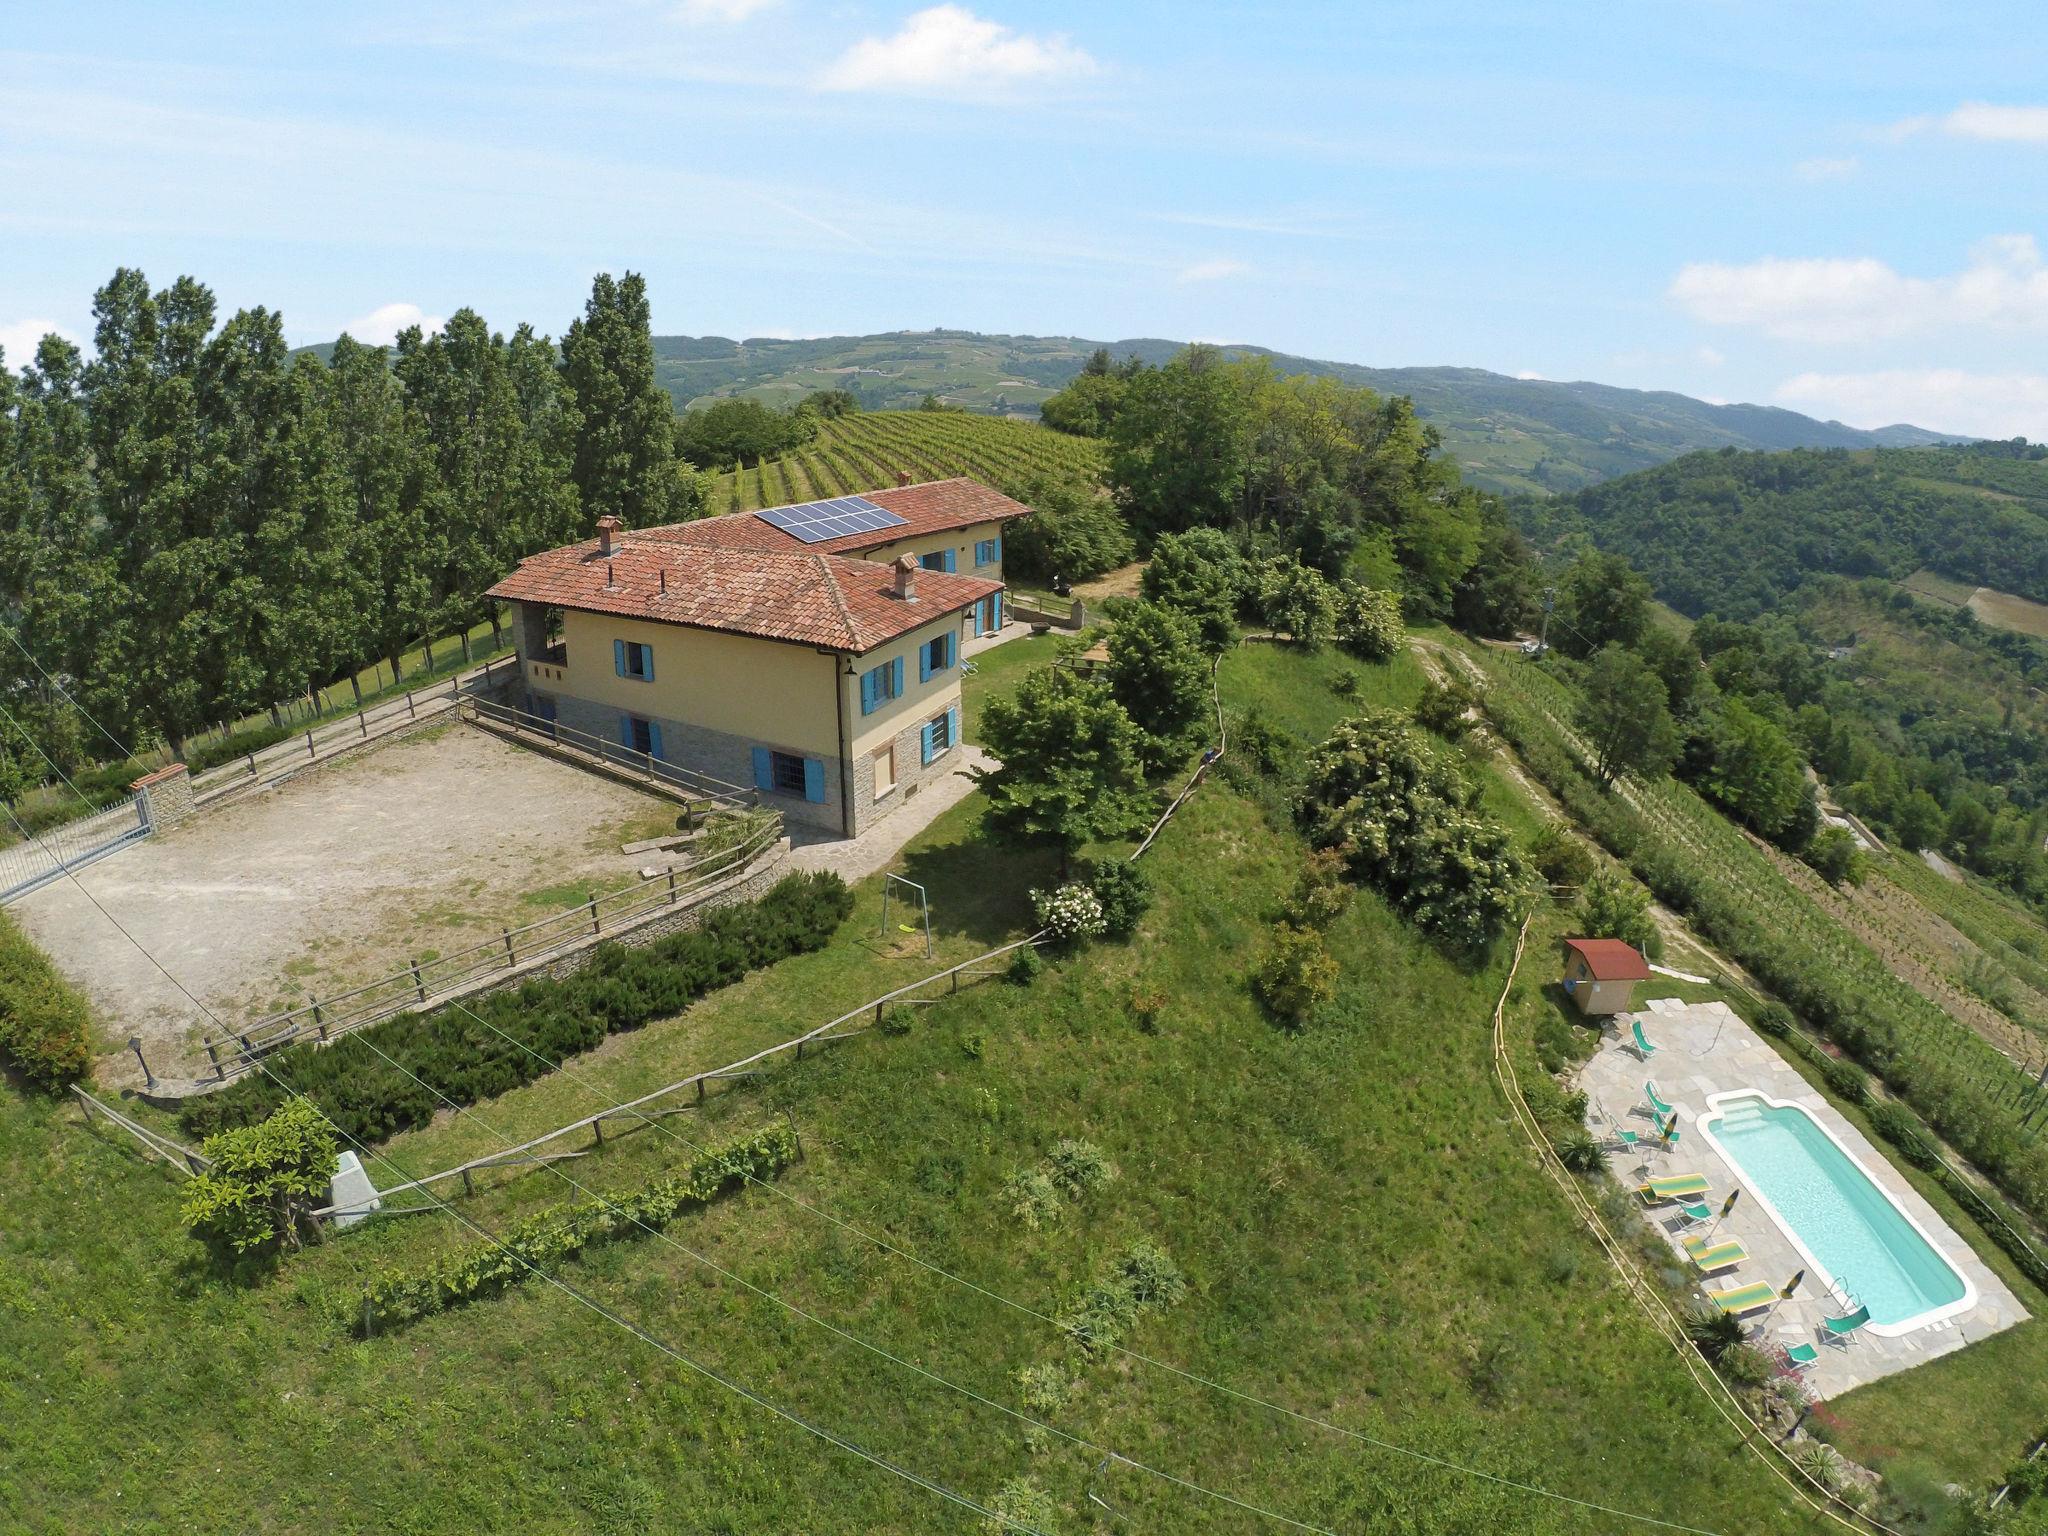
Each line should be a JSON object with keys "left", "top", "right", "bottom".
{"left": 653, "top": 330, "right": 1962, "bottom": 494}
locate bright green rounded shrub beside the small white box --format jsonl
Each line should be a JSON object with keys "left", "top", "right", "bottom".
{"left": 178, "top": 1098, "right": 336, "bottom": 1253}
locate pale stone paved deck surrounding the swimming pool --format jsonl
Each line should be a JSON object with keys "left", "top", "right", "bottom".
{"left": 1579, "top": 997, "right": 2028, "bottom": 1397}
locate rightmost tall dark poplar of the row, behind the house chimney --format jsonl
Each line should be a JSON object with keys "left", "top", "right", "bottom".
{"left": 561, "top": 272, "right": 682, "bottom": 528}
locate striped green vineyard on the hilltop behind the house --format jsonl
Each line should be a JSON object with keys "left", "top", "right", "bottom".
{"left": 709, "top": 412, "right": 1102, "bottom": 512}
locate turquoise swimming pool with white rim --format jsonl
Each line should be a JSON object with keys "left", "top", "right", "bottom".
{"left": 1700, "top": 1092, "right": 1976, "bottom": 1335}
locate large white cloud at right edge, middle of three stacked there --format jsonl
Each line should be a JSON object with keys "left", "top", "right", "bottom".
{"left": 1671, "top": 236, "right": 2048, "bottom": 342}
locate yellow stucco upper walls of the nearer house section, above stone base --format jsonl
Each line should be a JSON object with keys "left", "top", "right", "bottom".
{"left": 537, "top": 608, "right": 961, "bottom": 760}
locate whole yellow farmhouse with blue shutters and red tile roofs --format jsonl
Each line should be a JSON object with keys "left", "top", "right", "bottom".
{"left": 492, "top": 479, "right": 1028, "bottom": 838}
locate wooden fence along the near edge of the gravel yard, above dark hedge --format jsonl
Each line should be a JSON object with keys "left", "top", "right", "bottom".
{"left": 205, "top": 811, "right": 782, "bottom": 1081}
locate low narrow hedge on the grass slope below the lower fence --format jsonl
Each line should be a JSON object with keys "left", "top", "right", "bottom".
{"left": 342, "top": 1124, "right": 797, "bottom": 1335}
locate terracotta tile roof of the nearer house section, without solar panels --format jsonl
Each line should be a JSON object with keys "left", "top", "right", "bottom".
{"left": 489, "top": 536, "right": 1004, "bottom": 655}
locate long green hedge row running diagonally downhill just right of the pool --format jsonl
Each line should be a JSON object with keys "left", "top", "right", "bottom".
{"left": 1485, "top": 671, "right": 2048, "bottom": 1219}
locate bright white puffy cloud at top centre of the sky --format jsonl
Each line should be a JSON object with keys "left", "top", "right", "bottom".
{"left": 817, "top": 4, "right": 1098, "bottom": 96}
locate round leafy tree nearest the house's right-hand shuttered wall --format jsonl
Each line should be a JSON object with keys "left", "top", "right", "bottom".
{"left": 977, "top": 668, "right": 1153, "bottom": 879}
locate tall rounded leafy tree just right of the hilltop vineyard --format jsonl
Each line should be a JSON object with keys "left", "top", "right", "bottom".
{"left": 1106, "top": 346, "right": 1249, "bottom": 543}
